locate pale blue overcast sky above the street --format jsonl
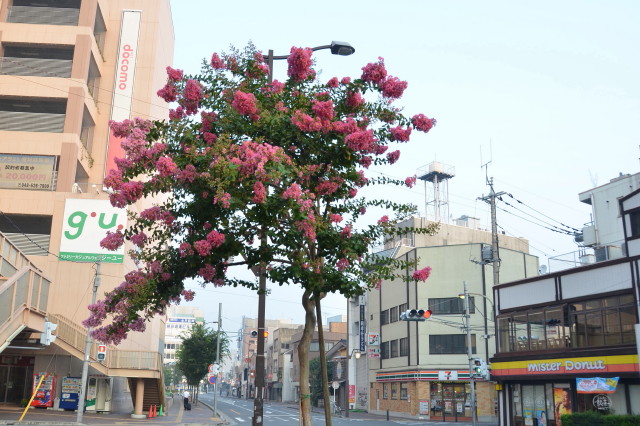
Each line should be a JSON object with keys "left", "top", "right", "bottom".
{"left": 171, "top": 0, "right": 640, "bottom": 330}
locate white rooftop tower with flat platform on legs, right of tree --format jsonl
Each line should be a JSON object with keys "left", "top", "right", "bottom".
{"left": 418, "top": 161, "right": 456, "bottom": 223}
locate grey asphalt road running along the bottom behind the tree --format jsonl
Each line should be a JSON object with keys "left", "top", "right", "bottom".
{"left": 200, "top": 393, "right": 489, "bottom": 426}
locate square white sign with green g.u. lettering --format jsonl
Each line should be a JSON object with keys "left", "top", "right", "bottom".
{"left": 60, "top": 198, "right": 127, "bottom": 263}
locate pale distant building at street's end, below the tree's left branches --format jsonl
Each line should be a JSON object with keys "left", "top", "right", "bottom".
{"left": 163, "top": 305, "right": 204, "bottom": 364}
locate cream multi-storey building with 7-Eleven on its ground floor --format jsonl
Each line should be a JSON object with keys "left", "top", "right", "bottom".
{"left": 368, "top": 218, "right": 538, "bottom": 422}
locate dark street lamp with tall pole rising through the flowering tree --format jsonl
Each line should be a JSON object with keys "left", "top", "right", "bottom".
{"left": 251, "top": 41, "right": 356, "bottom": 426}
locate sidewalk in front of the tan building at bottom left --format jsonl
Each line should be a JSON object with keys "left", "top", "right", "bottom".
{"left": 0, "top": 398, "right": 228, "bottom": 426}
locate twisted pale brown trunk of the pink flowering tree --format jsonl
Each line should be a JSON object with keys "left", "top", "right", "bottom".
{"left": 298, "top": 290, "right": 316, "bottom": 426}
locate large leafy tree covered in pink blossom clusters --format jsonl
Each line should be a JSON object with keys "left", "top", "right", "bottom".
{"left": 85, "top": 46, "right": 435, "bottom": 424}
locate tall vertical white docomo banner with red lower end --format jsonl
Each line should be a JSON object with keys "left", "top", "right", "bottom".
{"left": 104, "top": 10, "right": 142, "bottom": 180}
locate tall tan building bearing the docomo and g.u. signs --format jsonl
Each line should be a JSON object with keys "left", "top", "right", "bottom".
{"left": 0, "top": 0, "right": 174, "bottom": 415}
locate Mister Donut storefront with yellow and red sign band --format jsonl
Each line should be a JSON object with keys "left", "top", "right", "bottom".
{"left": 491, "top": 355, "right": 640, "bottom": 426}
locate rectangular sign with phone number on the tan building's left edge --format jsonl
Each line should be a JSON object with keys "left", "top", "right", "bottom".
{"left": 0, "top": 154, "right": 55, "bottom": 191}
